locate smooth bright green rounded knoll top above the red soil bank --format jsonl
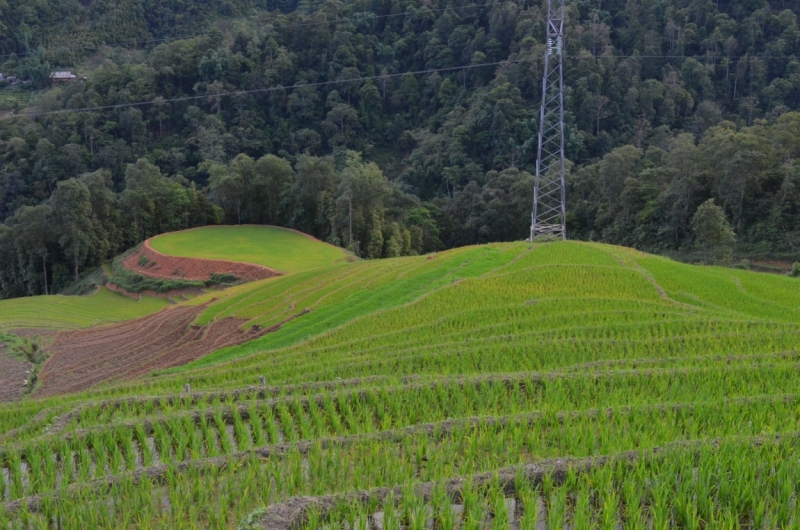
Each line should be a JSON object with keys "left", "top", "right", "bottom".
{"left": 150, "top": 226, "right": 346, "bottom": 273}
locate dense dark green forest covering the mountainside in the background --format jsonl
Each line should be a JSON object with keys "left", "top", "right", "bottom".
{"left": 0, "top": 0, "right": 800, "bottom": 297}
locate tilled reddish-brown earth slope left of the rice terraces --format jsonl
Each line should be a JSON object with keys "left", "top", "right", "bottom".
{"left": 34, "top": 306, "right": 279, "bottom": 396}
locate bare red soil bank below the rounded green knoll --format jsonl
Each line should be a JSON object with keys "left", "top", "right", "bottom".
{"left": 122, "top": 240, "right": 281, "bottom": 282}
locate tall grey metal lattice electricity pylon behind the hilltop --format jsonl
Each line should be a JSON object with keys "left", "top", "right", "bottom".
{"left": 530, "top": 0, "right": 567, "bottom": 241}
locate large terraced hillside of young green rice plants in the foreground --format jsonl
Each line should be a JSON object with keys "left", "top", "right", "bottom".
{"left": 0, "top": 237, "right": 800, "bottom": 530}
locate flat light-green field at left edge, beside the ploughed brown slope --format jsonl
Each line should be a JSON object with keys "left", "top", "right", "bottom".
{"left": 0, "top": 287, "right": 169, "bottom": 329}
